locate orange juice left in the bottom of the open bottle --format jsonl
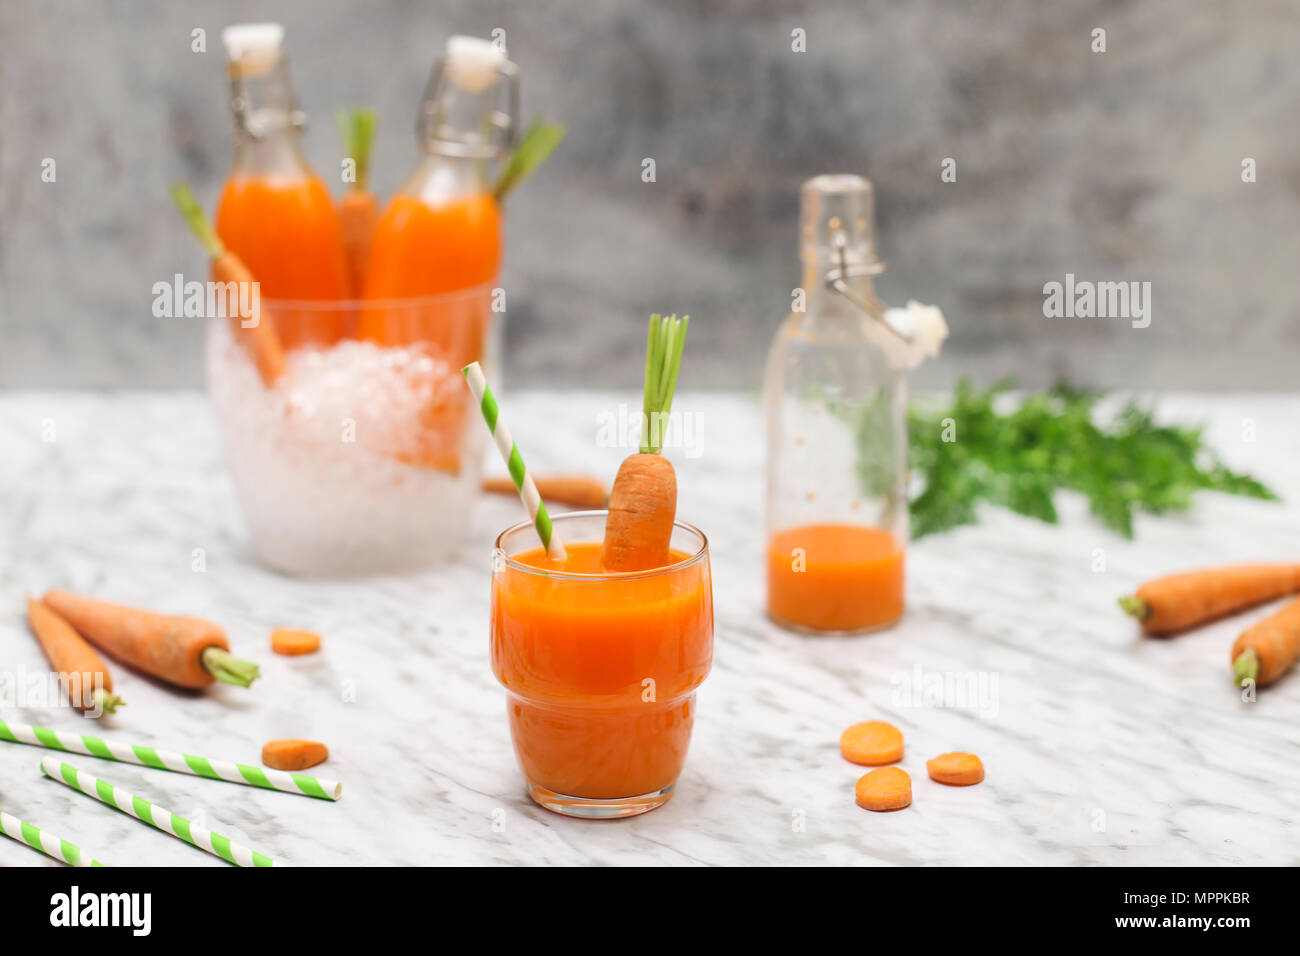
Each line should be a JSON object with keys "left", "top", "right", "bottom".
{"left": 767, "top": 524, "right": 904, "bottom": 632}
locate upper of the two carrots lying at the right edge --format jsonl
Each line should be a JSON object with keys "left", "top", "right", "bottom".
{"left": 1119, "top": 564, "right": 1300, "bottom": 635}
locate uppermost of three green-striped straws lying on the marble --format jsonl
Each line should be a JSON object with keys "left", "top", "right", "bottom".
{"left": 0, "top": 721, "right": 343, "bottom": 800}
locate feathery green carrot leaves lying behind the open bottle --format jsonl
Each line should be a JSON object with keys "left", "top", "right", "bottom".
{"left": 899, "top": 380, "right": 1277, "bottom": 538}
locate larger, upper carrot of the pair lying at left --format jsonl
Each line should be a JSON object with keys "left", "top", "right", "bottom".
{"left": 44, "top": 591, "right": 257, "bottom": 688}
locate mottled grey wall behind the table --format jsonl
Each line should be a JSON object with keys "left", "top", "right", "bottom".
{"left": 0, "top": 0, "right": 1300, "bottom": 388}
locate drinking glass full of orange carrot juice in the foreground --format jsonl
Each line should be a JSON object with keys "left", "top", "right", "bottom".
{"left": 491, "top": 511, "right": 714, "bottom": 818}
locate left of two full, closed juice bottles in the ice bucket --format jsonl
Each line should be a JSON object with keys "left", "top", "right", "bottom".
{"left": 216, "top": 23, "right": 348, "bottom": 349}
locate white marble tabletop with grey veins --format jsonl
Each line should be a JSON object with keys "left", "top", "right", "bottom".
{"left": 0, "top": 393, "right": 1300, "bottom": 865}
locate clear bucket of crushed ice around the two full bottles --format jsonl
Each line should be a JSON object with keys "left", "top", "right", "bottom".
{"left": 205, "top": 286, "right": 498, "bottom": 576}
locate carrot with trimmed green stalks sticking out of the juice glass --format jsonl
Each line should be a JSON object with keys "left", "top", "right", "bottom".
{"left": 603, "top": 315, "right": 690, "bottom": 571}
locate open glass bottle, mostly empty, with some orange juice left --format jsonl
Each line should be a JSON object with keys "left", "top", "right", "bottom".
{"left": 764, "top": 176, "right": 907, "bottom": 633}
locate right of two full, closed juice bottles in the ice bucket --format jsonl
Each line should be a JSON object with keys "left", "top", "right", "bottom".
{"left": 358, "top": 36, "right": 517, "bottom": 368}
